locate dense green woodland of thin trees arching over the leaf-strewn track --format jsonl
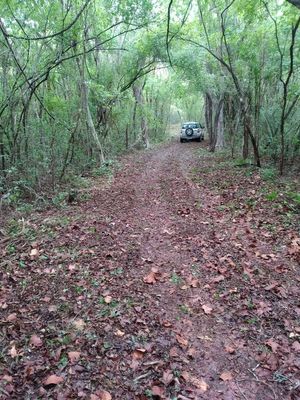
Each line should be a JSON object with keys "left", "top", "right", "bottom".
{"left": 0, "top": 0, "right": 300, "bottom": 203}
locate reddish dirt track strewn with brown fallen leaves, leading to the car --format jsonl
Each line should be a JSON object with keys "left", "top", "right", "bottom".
{"left": 0, "top": 142, "right": 300, "bottom": 400}
